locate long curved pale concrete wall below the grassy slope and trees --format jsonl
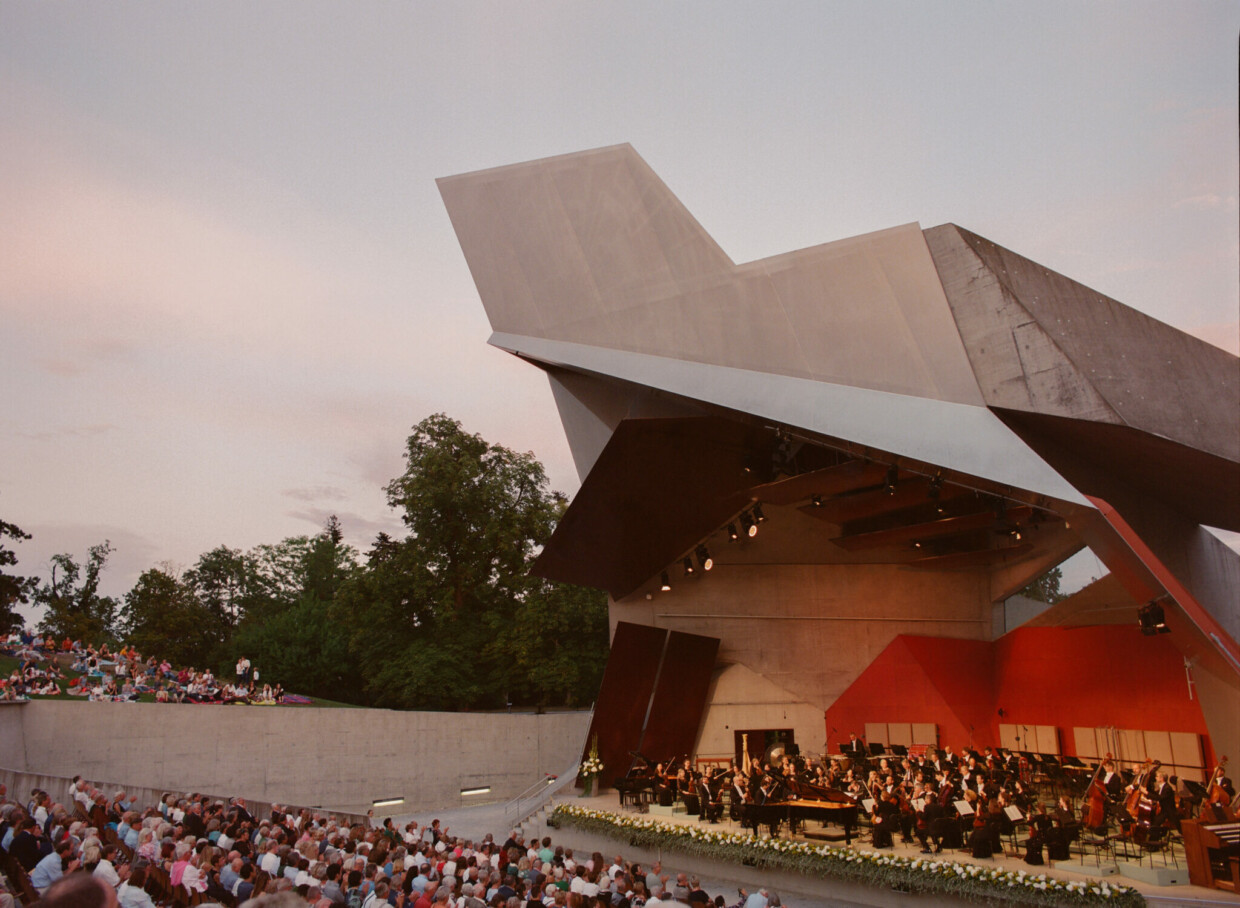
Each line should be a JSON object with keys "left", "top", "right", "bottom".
{"left": 0, "top": 700, "right": 589, "bottom": 812}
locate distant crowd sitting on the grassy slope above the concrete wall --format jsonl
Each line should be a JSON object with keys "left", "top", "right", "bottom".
{"left": 0, "top": 631, "right": 285, "bottom": 703}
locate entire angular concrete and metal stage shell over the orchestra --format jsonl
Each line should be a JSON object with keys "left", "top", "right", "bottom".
{"left": 439, "top": 145, "right": 1240, "bottom": 772}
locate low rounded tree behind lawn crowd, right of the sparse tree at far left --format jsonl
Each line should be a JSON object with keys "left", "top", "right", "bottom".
{"left": 119, "top": 568, "right": 231, "bottom": 669}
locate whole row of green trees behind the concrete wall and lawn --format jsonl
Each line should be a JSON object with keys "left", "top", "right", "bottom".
{"left": 8, "top": 413, "right": 608, "bottom": 710}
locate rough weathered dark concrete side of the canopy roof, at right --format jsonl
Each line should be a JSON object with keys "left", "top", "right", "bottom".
{"left": 925, "top": 225, "right": 1240, "bottom": 461}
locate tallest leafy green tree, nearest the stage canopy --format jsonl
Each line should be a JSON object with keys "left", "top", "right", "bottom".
{"left": 340, "top": 413, "right": 606, "bottom": 708}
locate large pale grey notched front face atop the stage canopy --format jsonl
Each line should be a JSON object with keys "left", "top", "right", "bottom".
{"left": 439, "top": 145, "right": 982, "bottom": 404}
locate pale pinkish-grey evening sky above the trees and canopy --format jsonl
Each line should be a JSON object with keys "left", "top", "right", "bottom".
{"left": 0, "top": 0, "right": 1240, "bottom": 617}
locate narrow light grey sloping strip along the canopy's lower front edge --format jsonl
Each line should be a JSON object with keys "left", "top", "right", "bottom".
{"left": 490, "top": 332, "right": 1090, "bottom": 506}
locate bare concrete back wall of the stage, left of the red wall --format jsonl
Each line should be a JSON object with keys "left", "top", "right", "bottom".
{"left": 610, "top": 553, "right": 992, "bottom": 755}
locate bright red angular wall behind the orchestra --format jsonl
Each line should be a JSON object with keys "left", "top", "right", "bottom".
{"left": 826, "top": 625, "right": 1214, "bottom": 764}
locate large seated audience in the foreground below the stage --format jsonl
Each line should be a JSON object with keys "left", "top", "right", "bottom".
{"left": 0, "top": 778, "right": 780, "bottom": 908}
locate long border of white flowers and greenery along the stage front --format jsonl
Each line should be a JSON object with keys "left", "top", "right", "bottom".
{"left": 547, "top": 804, "right": 1146, "bottom": 908}
